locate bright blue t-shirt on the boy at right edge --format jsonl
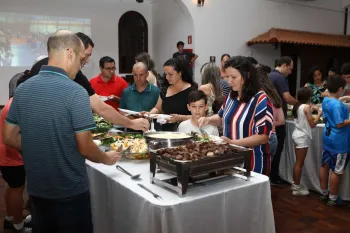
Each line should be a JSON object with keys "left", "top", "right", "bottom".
{"left": 322, "top": 97, "right": 350, "bottom": 154}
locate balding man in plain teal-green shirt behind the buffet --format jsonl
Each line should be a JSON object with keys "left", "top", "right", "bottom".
{"left": 120, "top": 62, "right": 160, "bottom": 112}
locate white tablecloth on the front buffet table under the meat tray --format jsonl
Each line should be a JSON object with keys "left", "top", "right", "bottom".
{"left": 87, "top": 160, "right": 275, "bottom": 233}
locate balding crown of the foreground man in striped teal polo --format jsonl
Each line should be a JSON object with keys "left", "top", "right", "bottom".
{"left": 47, "top": 30, "right": 83, "bottom": 54}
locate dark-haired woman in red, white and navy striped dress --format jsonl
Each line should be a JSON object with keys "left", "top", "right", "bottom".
{"left": 199, "top": 56, "right": 273, "bottom": 175}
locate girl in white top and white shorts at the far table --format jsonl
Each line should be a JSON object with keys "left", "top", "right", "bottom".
{"left": 291, "top": 87, "right": 322, "bottom": 196}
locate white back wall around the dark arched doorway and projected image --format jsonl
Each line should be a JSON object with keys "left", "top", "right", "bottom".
{"left": 0, "top": 0, "right": 153, "bottom": 105}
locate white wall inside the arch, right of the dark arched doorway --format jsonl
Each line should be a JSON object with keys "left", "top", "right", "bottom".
{"left": 151, "top": 0, "right": 196, "bottom": 73}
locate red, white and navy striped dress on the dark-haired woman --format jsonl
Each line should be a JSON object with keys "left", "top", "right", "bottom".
{"left": 218, "top": 91, "right": 273, "bottom": 175}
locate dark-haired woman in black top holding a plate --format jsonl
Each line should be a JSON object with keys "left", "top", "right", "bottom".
{"left": 150, "top": 57, "right": 198, "bottom": 131}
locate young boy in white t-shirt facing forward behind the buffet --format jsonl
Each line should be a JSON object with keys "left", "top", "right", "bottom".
{"left": 177, "top": 91, "right": 219, "bottom": 136}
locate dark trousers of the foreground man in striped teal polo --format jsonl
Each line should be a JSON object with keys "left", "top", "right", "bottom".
{"left": 30, "top": 192, "right": 93, "bottom": 233}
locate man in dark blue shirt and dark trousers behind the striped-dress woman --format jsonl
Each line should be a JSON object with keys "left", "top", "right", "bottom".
{"left": 269, "top": 57, "right": 298, "bottom": 184}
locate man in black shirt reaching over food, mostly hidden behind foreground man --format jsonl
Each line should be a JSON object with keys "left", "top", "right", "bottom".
{"left": 22, "top": 32, "right": 150, "bottom": 131}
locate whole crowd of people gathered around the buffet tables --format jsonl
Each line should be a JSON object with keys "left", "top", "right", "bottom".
{"left": 0, "top": 30, "right": 350, "bottom": 232}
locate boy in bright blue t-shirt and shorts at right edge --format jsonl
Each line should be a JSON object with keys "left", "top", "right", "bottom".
{"left": 320, "top": 75, "right": 350, "bottom": 206}
